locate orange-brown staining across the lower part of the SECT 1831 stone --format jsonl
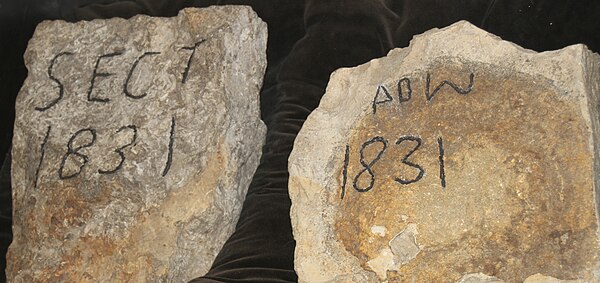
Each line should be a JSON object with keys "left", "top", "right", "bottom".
{"left": 8, "top": 136, "right": 229, "bottom": 282}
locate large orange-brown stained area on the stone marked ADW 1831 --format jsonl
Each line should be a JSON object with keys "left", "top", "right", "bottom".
{"left": 335, "top": 59, "right": 599, "bottom": 282}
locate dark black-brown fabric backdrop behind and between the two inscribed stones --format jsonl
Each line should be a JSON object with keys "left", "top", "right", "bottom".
{"left": 0, "top": 0, "right": 600, "bottom": 282}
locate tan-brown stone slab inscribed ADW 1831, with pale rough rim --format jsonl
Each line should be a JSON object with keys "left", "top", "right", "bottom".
{"left": 289, "top": 22, "right": 600, "bottom": 282}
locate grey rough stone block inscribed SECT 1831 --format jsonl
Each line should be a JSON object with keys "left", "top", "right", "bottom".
{"left": 7, "top": 6, "right": 267, "bottom": 282}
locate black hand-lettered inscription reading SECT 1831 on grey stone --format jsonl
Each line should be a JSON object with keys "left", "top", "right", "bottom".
{"left": 33, "top": 39, "right": 207, "bottom": 188}
